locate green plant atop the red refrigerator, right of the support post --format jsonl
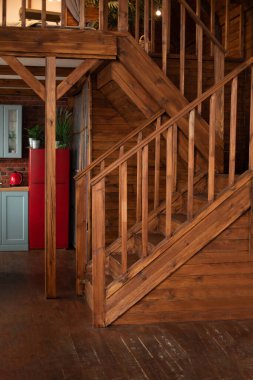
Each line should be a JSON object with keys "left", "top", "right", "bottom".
{"left": 56, "top": 107, "right": 72, "bottom": 148}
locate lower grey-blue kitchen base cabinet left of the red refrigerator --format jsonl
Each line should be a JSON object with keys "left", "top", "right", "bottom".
{"left": 0, "top": 191, "right": 28, "bottom": 251}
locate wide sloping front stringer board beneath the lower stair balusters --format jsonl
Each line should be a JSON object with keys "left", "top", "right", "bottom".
{"left": 105, "top": 172, "right": 253, "bottom": 325}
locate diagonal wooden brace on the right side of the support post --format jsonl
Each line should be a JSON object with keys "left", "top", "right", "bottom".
{"left": 56, "top": 59, "right": 100, "bottom": 100}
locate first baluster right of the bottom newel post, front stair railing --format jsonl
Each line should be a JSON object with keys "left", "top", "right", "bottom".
{"left": 119, "top": 155, "right": 127, "bottom": 273}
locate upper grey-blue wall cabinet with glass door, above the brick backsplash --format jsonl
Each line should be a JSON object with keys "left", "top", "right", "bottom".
{"left": 0, "top": 105, "right": 22, "bottom": 158}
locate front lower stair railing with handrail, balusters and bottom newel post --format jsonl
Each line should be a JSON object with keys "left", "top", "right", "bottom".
{"left": 83, "top": 58, "right": 253, "bottom": 326}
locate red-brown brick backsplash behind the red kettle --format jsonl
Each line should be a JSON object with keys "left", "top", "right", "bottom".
{"left": 0, "top": 158, "right": 28, "bottom": 186}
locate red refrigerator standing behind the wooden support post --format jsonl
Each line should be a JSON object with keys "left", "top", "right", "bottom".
{"left": 29, "top": 149, "right": 70, "bottom": 249}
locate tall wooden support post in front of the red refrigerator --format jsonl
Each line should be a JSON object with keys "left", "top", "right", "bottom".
{"left": 45, "top": 57, "right": 56, "bottom": 298}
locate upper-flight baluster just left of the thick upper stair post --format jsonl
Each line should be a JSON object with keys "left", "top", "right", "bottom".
{"left": 196, "top": 0, "right": 203, "bottom": 114}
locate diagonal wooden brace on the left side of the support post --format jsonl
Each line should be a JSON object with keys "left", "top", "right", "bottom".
{"left": 1, "top": 56, "right": 45, "bottom": 101}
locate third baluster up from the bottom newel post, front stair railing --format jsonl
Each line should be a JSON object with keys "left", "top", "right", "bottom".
{"left": 165, "top": 127, "right": 173, "bottom": 238}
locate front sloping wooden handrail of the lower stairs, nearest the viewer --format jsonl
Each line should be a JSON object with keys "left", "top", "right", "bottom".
{"left": 90, "top": 57, "right": 253, "bottom": 186}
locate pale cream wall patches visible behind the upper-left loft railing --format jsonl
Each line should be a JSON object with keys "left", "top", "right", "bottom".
{"left": 0, "top": 0, "right": 61, "bottom": 24}
